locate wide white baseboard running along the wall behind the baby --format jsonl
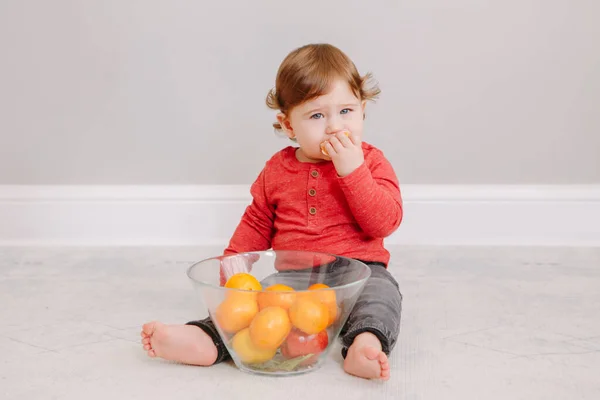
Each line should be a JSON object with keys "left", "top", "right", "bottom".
{"left": 0, "top": 185, "right": 600, "bottom": 246}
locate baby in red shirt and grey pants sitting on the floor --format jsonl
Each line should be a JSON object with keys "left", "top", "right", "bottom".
{"left": 141, "top": 44, "right": 403, "bottom": 380}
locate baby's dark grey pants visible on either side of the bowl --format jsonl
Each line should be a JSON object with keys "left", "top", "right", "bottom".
{"left": 186, "top": 261, "right": 402, "bottom": 364}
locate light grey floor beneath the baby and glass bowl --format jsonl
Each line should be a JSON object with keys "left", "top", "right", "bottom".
{"left": 0, "top": 247, "right": 600, "bottom": 400}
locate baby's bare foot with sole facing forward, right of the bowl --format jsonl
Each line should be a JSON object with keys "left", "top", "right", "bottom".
{"left": 344, "top": 332, "right": 390, "bottom": 381}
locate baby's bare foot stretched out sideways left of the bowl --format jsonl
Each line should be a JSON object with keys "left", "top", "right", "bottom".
{"left": 141, "top": 321, "right": 217, "bottom": 366}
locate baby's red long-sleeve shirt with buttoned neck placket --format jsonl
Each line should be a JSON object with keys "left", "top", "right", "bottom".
{"left": 224, "top": 142, "right": 403, "bottom": 265}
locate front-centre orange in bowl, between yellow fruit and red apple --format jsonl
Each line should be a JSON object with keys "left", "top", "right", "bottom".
{"left": 249, "top": 307, "right": 292, "bottom": 350}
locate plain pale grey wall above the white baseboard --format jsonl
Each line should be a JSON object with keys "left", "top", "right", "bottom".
{"left": 0, "top": 0, "right": 600, "bottom": 184}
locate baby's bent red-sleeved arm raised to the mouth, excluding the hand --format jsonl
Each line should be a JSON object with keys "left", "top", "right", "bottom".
{"left": 339, "top": 153, "right": 403, "bottom": 238}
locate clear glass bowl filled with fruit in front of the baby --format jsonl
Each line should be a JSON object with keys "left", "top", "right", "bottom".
{"left": 187, "top": 251, "right": 371, "bottom": 376}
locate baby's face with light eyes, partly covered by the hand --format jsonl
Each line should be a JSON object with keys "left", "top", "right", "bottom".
{"left": 278, "top": 79, "right": 365, "bottom": 162}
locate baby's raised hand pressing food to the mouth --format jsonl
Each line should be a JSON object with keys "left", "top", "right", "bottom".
{"left": 325, "top": 131, "right": 365, "bottom": 177}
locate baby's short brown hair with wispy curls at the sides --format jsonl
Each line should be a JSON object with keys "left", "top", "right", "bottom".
{"left": 266, "top": 44, "right": 380, "bottom": 130}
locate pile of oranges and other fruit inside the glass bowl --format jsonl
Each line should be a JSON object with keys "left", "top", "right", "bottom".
{"left": 214, "top": 273, "right": 338, "bottom": 364}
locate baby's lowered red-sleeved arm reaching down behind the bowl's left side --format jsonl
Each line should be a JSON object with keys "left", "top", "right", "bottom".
{"left": 224, "top": 169, "right": 275, "bottom": 255}
